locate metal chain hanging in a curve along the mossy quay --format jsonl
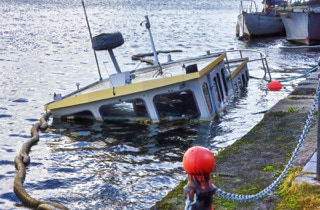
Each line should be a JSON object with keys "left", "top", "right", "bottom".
{"left": 216, "top": 80, "right": 320, "bottom": 202}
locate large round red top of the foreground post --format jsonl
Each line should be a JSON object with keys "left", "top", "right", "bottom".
{"left": 183, "top": 146, "right": 216, "bottom": 175}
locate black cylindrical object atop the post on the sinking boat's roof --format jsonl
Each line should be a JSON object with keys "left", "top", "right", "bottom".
{"left": 92, "top": 32, "right": 124, "bottom": 51}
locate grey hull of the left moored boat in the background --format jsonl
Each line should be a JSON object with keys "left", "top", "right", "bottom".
{"left": 238, "top": 11, "right": 285, "bottom": 37}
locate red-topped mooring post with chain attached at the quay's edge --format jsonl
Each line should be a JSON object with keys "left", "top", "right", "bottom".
{"left": 183, "top": 146, "right": 216, "bottom": 210}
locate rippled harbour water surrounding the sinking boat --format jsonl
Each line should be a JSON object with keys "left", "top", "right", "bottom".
{"left": 0, "top": 0, "right": 319, "bottom": 209}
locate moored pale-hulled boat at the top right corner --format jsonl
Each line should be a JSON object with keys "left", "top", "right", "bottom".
{"left": 279, "top": 0, "right": 320, "bottom": 45}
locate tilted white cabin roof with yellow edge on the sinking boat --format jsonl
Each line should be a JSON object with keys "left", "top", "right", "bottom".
{"left": 45, "top": 54, "right": 230, "bottom": 110}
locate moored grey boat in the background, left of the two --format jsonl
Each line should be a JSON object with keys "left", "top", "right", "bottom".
{"left": 237, "top": 0, "right": 285, "bottom": 37}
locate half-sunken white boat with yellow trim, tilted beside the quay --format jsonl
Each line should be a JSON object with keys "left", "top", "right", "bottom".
{"left": 44, "top": 16, "right": 271, "bottom": 124}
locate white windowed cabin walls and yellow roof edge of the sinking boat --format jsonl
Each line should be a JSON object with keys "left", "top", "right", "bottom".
{"left": 45, "top": 54, "right": 249, "bottom": 124}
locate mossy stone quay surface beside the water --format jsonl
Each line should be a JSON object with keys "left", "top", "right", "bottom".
{"left": 151, "top": 66, "right": 320, "bottom": 210}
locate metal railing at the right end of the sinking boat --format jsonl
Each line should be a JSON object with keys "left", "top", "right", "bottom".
{"left": 225, "top": 49, "right": 271, "bottom": 81}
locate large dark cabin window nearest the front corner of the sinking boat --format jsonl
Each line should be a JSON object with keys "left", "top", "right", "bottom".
{"left": 153, "top": 90, "right": 200, "bottom": 121}
